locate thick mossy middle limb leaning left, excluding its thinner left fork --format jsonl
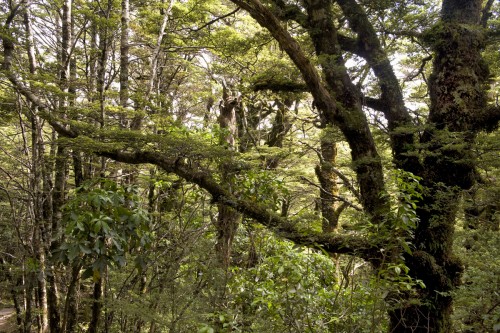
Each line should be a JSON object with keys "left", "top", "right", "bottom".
{"left": 300, "top": 0, "right": 389, "bottom": 223}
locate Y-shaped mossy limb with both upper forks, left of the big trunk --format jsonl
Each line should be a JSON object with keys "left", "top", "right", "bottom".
{"left": 232, "top": 0, "right": 389, "bottom": 221}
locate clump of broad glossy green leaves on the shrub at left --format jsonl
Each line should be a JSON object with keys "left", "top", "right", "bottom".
{"left": 58, "top": 179, "right": 151, "bottom": 279}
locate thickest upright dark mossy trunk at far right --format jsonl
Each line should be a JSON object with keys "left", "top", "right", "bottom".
{"left": 390, "top": 0, "right": 488, "bottom": 333}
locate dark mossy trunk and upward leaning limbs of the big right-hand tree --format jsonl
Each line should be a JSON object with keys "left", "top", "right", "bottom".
{"left": 233, "top": 0, "right": 498, "bottom": 332}
